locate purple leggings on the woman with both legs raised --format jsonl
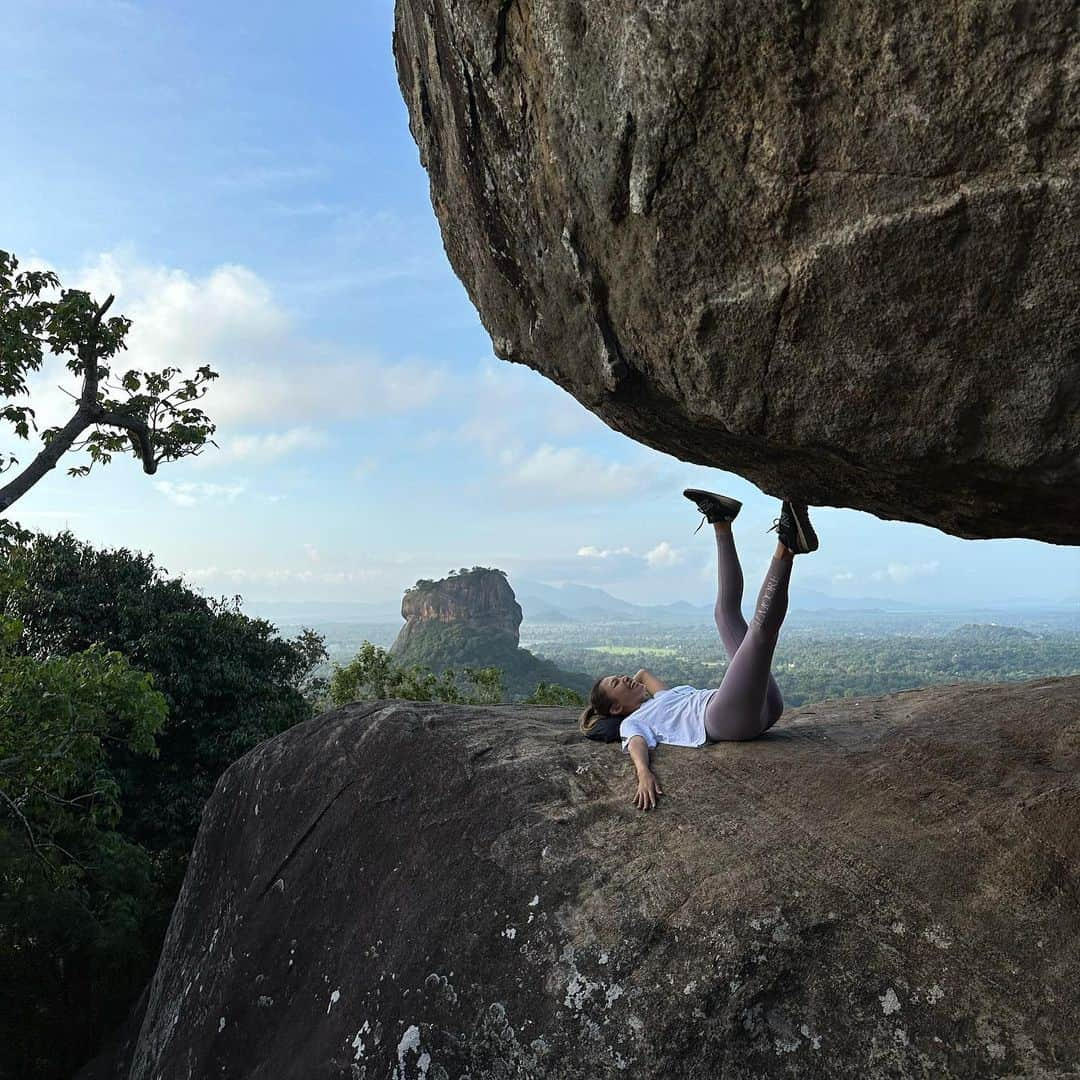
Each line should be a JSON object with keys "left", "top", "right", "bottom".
{"left": 705, "top": 530, "right": 792, "bottom": 742}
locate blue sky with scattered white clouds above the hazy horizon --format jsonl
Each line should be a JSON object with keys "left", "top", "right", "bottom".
{"left": 0, "top": 0, "right": 1080, "bottom": 605}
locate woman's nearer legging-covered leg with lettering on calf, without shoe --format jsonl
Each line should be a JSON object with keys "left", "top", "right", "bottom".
{"left": 705, "top": 544, "right": 794, "bottom": 740}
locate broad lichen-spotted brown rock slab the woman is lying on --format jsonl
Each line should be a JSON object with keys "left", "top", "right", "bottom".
{"left": 83, "top": 678, "right": 1080, "bottom": 1080}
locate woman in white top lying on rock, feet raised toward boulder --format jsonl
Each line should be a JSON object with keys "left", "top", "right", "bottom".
{"left": 581, "top": 488, "right": 818, "bottom": 810}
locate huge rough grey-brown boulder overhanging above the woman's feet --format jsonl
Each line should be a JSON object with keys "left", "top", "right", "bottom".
{"left": 394, "top": 0, "right": 1080, "bottom": 543}
